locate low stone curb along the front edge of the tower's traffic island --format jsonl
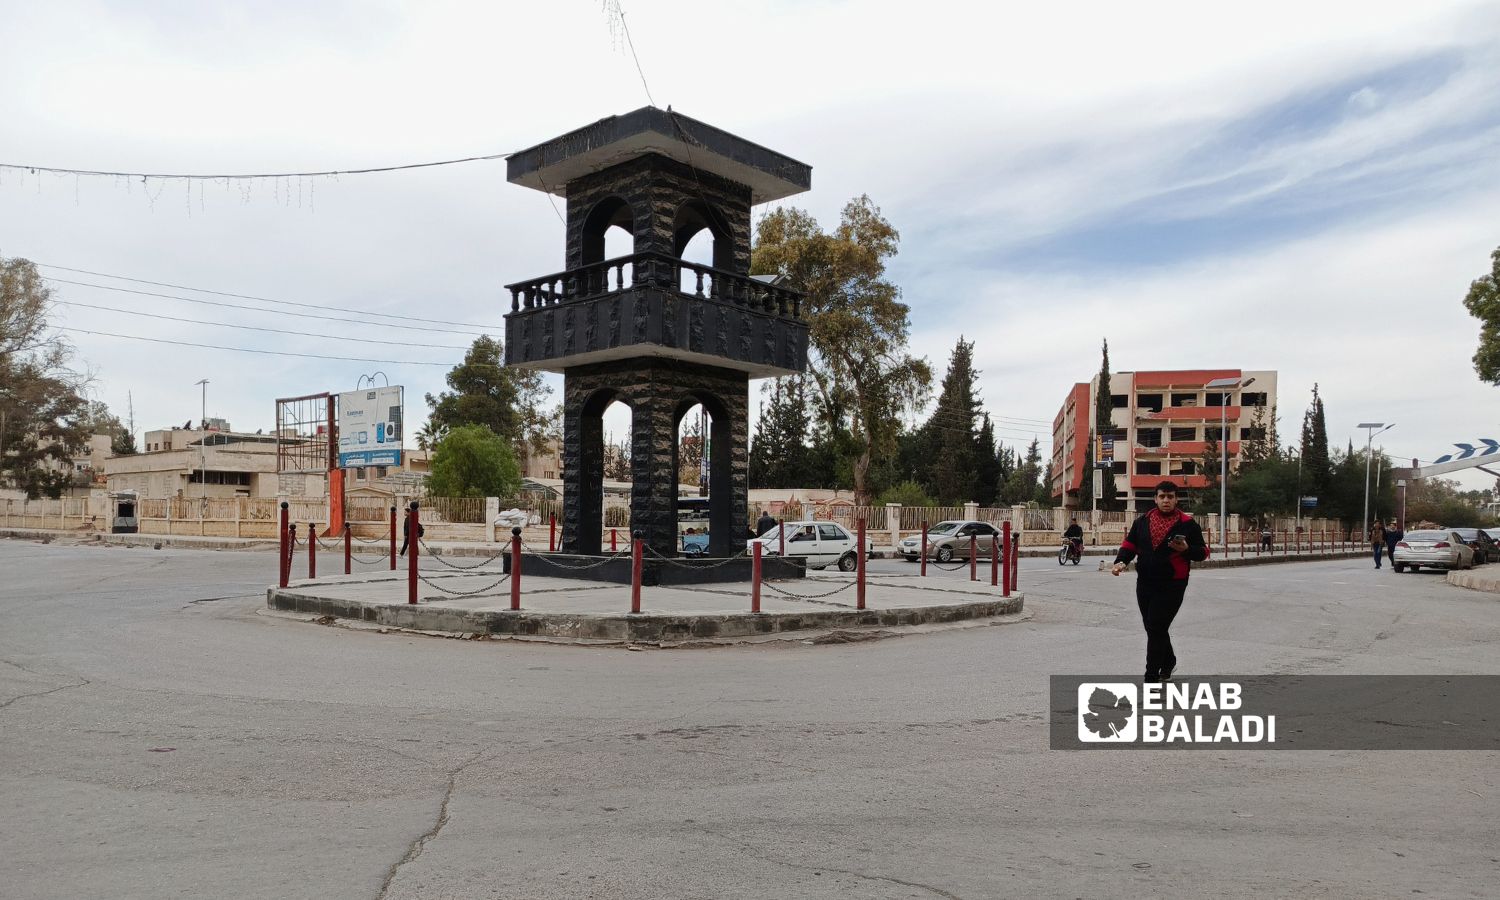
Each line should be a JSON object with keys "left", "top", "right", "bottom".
{"left": 266, "top": 588, "right": 1025, "bottom": 644}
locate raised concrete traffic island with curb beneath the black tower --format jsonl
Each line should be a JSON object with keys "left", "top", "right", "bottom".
{"left": 266, "top": 567, "right": 1023, "bottom": 644}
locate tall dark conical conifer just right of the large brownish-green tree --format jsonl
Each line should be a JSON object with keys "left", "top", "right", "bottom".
{"left": 921, "top": 336, "right": 993, "bottom": 504}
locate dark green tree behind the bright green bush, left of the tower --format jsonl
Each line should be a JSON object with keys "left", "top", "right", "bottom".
{"left": 419, "top": 335, "right": 557, "bottom": 455}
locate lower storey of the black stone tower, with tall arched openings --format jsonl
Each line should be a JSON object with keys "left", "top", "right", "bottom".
{"left": 563, "top": 359, "right": 750, "bottom": 557}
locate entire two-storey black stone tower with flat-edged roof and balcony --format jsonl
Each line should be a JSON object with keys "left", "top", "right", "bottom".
{"left": 506, "top": 107, "right": 812, "bottom": 557}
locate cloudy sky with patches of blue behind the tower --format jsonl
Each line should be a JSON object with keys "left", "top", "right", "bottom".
{"left": 0, "top": 0, "right": 1500, "bottom": 488}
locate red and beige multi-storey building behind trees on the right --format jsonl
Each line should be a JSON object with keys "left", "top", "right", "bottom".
{"left": 1052, "top": 369, "right": 1277, "bottom": 512}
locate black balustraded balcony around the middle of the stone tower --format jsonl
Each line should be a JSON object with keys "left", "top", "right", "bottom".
{"left": 506, "top": 254, "right": 807, "bottom": 378}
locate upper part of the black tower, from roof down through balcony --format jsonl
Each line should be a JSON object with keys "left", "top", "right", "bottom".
{"left": 506, "top": 107, "right": 812, "bottom": 375}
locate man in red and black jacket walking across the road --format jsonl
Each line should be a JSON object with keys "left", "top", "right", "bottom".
{"left": 1110, "top": 482, "right": 1209, "bottom": 681}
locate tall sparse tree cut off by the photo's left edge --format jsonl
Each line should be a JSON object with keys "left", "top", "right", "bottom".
{"left": 0, "top": 258, "right": 92, "bottom": 498}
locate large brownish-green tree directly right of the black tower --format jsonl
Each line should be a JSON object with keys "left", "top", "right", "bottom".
{"left": 750, "top": 197, "right": 932, "bottom": 504}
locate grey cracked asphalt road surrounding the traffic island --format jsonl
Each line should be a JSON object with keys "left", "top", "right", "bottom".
{"left": 0, "top": 542, "right": 1500, "bottom": 900}
